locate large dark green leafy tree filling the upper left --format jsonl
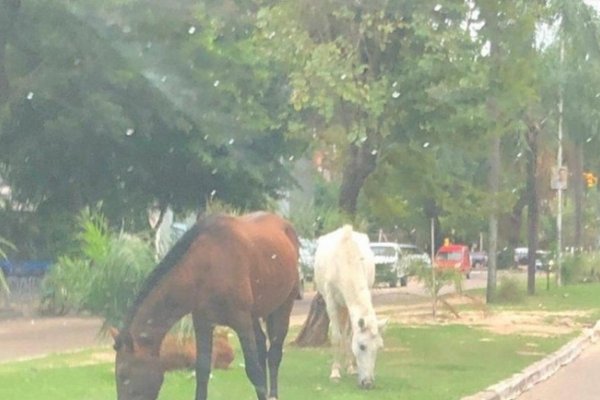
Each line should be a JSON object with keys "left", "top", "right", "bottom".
{"left": 0, "top": 1, "right": 298, "bottom": 256}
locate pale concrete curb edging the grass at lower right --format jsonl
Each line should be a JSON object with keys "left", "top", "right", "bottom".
{"left": 461, "top": 321, "right": 600, "bottom": 400}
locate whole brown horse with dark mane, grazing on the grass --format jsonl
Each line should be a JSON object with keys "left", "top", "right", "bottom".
{"left": 113, "top": 212, "right": 298, "bottom": 400}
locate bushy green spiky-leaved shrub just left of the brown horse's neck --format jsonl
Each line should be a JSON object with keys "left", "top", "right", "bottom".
{"left": 41, "top": 211, "right": 154, "bottom": 326}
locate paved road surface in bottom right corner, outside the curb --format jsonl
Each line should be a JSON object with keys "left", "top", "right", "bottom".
{"left": 518, "top": 341, "right": 600, "bottom": 400}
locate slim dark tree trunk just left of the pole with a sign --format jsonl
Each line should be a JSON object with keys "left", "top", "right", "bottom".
{"left": 526, "top": 126, "right": 539, "bottom": 295}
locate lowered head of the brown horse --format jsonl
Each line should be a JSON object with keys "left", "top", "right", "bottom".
{"left": 111, "top": 330, "right": 164, "bottom": 400}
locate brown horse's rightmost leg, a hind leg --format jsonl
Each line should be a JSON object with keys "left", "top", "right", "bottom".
{"left": 267, "top": 293, "right": 296, "bottom": 399}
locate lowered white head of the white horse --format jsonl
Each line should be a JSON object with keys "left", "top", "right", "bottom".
{"left": 352, "top": 318, "right": 387, "bottom": 389}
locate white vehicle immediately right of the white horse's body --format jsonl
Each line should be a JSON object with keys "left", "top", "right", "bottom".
{"left": 370, "top": 242, "right": 408, "bottom": 287}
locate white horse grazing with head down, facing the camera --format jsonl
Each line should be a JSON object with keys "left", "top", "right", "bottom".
{"left": 314, "top": 225, "right": 386, "bottom": 389}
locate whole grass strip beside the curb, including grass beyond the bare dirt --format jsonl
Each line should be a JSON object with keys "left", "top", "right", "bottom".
{"left": 0, "top": 280, "right": 600, "bottom": 400}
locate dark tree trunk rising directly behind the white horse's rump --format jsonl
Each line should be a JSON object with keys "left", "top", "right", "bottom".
{"left": 338, "top": 140, "right": 377, "bottom": 217}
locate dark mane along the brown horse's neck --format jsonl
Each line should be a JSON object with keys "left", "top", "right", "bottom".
{"left": 122, "top": 216, "right": 217, "bottom": 331}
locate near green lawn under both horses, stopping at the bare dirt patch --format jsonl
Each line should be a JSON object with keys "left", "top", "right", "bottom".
{"left": 0, "top": 325, "right": 568, "bottom": 400}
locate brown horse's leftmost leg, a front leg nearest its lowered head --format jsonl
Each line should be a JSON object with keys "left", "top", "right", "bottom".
{"left": 192, "top": 314, "right": 214, "bottom": 400}
